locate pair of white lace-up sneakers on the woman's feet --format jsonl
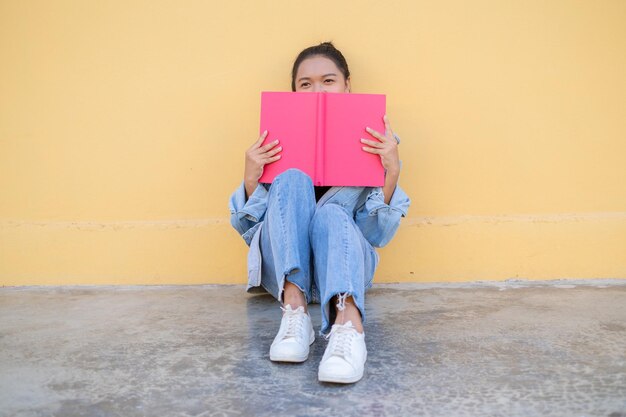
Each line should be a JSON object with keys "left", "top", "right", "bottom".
{"left": 270, "top": 304, "right": 367, "bottom": 384}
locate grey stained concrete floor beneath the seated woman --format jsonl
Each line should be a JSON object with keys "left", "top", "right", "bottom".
{"left": 0, "top": 280, "right": 626, "bottom": 417}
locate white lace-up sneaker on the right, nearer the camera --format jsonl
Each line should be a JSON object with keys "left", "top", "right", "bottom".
{"left": 317, "top": 321, "right": 367, "bottom": 384}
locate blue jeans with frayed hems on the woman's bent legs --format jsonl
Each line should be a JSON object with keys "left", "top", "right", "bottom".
{"left": 260, "top": 169, "right": 377, "bottom": 334}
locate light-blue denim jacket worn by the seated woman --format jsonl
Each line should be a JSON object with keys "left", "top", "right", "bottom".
{"left": 229, "top": 178, "right": 411, "bottom": 292}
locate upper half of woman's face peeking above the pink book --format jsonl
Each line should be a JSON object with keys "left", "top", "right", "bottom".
{"left": 296, "top": 55, "right": 350, "bottom": 93}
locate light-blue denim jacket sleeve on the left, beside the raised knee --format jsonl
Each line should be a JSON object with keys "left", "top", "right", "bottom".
{"left": 228, "top": 181, "right": 268, "bottom": 245}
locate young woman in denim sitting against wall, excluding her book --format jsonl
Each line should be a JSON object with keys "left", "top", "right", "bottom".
{"left": 230, "top": 42, "right": 410, "bottom": 383}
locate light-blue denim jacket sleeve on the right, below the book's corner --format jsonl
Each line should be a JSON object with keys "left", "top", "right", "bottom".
{"left": 355, "top": 185, "right": 411, "bottom": 248}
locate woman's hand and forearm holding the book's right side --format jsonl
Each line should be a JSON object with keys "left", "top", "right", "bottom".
{"left": 361, "top": 115, "right": 400, "bottom": 204}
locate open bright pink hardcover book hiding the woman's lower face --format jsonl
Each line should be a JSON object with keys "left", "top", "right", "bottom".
{"left": 259, "top": 92, "right": 386, "bottom": 187}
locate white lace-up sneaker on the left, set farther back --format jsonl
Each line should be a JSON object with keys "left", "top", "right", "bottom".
{"left": 270, "top": 304, "right": 315, "bottom": 362}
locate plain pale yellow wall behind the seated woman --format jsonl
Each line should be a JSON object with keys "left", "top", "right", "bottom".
{"left": 0, "top": 0, "right": 626, "bottom": 285}
